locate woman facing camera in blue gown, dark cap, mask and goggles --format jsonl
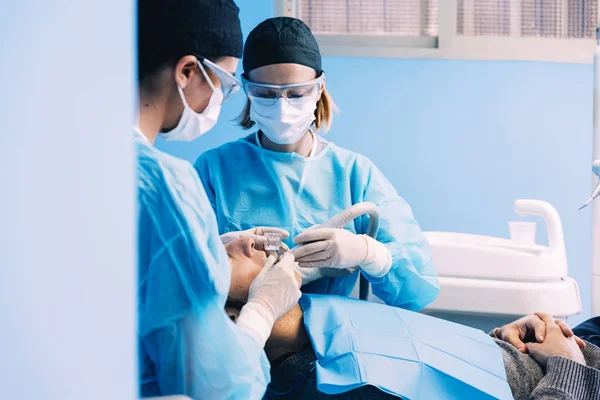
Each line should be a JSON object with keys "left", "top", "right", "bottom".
{"left": 195, "top": 17, "right": 439, "bottom": 310}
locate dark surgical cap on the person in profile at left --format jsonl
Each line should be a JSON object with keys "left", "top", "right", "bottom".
{"left": 138, "top": 0, "right": 242, "bottom": 80}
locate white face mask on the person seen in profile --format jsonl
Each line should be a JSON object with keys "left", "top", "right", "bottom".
{"left": 160, "top": 86, "right": 223, "bottom": 142}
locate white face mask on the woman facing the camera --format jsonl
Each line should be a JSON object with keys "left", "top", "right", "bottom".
{"left": 250, "top": 97, "right": 317, "bottom": 144}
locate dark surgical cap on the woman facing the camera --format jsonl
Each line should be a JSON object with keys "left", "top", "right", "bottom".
{"left": 244, "top": 17, "right": 323, "bottom": 74}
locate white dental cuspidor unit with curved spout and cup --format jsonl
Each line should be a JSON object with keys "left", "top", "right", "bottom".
{"left": 425, "top": 200, "right": 581, "bottom": 330}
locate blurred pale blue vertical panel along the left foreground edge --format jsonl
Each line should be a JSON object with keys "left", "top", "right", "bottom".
{"left": 0, "top": 0, "right": 137, "bottom": 400}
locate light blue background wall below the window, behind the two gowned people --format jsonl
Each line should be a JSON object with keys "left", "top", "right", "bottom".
{"left": 159, "top": 0, "right": 593, "bottom": 321}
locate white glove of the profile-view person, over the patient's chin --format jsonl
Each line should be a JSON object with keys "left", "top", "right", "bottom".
{"left": 237, "top": 253, "right": 302, "bottom": 347}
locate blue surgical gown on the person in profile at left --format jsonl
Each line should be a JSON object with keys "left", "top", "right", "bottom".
{"left": 136, "top": 135, "right": 270, "bottom": 399}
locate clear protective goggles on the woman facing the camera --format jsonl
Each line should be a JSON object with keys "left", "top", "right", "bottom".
{"left": 242, "top": 74, "right": 325, "bottom": 104}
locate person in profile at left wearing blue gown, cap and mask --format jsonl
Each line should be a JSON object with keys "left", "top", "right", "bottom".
{"left": 134, "top": 0, "right": 301, "bottom": 399}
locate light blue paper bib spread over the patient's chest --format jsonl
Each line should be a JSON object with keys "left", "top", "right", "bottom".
{"left": 300, "top": 295, "right": 513, "bottom": 400}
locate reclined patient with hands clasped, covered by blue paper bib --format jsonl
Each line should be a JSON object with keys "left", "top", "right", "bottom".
{"left": 226, "top": 238, "right": 600, "bottom": 400}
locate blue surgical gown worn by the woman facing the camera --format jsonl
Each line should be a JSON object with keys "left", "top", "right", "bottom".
{"left": 194, "top": 134, "right": 439, "bottom": 310}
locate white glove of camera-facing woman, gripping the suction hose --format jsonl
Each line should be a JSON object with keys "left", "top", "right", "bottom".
{"left": 291, "top": 228, "right": 392, "bottom": 278}
